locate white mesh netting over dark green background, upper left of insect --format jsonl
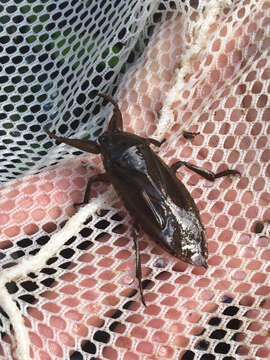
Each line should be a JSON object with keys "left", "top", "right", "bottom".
{"left": 0, "top": 0, "right": 162, "bottom": 182}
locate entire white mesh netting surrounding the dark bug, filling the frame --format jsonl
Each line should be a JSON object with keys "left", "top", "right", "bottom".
{"left": 0, "top": 0, "right": 270, "bottom": 360}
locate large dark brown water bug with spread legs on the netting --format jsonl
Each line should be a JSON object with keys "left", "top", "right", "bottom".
{"left": 46, "top": 94, "right": 240, "bottom": 306}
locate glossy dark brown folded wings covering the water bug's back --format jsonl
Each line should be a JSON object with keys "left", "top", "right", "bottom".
{"left": 107, "top": 145, "right": 207, "bottom": 266}
